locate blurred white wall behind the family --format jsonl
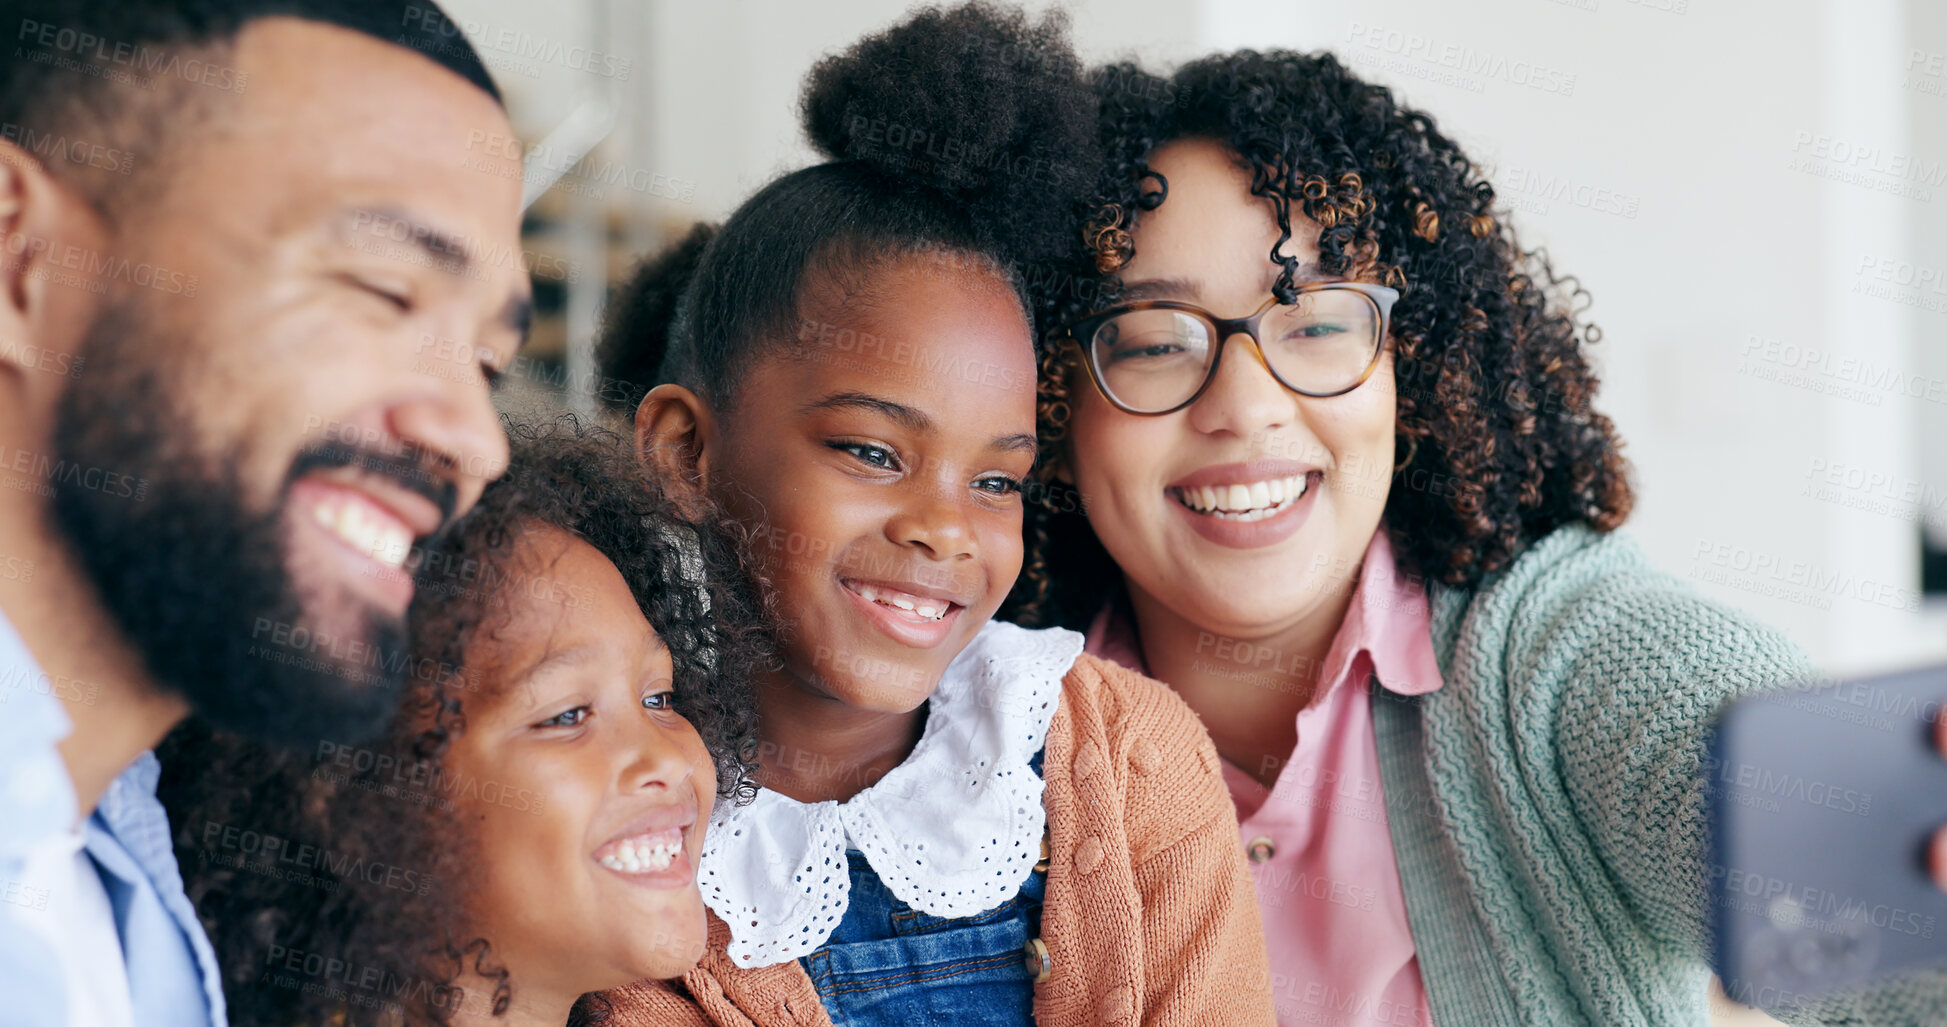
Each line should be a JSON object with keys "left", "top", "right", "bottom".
{"left": 448, "top": 0, "right": 1947, "bottom": 672}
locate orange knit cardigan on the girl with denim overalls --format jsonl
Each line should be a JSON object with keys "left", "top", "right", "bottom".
{"left": 607, "top": 655, "right": 1273, "bottom": 1027}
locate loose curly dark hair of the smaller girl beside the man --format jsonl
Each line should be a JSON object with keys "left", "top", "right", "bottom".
{"left": 158, "top": 415, "right": 775, "bottom": 1027}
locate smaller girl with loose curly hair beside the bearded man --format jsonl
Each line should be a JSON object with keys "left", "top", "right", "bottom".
{"left": 164, "top": 419, "right": 767, "bottom": 1027}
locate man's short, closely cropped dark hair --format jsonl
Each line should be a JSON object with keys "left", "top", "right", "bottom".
{"left": 0, "top": 0, "right": 500, "bottom": 209}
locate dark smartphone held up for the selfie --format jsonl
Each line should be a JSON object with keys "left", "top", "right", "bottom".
{"left": 1702, "top": 666, "right": 1947, "bottom": 1009}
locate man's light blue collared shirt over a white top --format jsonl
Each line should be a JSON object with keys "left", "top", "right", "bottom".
{"left": 0, "top": 614, "right": 224, "bottom": 1027}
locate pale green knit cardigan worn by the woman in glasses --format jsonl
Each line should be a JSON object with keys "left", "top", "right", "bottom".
{"left": 1373, "top": 526, "right": 1947, "bottom": 1027}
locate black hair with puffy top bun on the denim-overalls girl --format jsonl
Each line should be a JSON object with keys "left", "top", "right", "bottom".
{"left": 598, "top": 2, "right": 1096, "bottom": 413}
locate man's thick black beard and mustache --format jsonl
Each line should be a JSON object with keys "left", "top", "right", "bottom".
{"left": 53, "top": 300, "right": 452, "bottom": 748}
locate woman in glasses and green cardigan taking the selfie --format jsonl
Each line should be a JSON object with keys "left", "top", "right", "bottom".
{"left": 1010, "top": 53, "right": 1947, "bottom": 1025}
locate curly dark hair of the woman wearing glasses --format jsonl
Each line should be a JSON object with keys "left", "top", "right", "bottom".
{"left": 1005, "top": 51, "right": 1632, "bottom": 626}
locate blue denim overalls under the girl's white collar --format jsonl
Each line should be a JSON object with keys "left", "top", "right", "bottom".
{"left": 798, "top": 752, "right": 1047, "bottom": 1027}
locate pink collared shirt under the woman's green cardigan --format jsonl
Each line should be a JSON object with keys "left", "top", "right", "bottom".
{"left": 1088, "top": 524, "right": 1441, "bottom": 1027}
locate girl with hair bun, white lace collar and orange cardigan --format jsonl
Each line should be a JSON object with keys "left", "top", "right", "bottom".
{"left": 607, "top": 6, "right": 1269, "bottom": 1027}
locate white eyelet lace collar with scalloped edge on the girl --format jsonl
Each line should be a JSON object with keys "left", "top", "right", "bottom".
{"left": 697, "top": 622, "right": 1083, "bottom": 969}
